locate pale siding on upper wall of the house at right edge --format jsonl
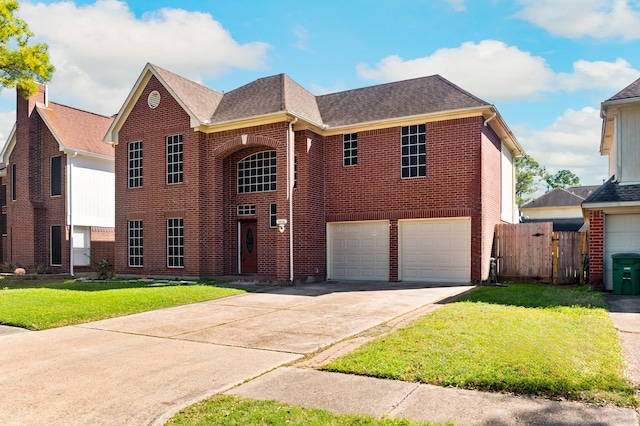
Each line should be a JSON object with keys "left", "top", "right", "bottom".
{"left": 616, "top": 108, "right": 640, "bottom": 183}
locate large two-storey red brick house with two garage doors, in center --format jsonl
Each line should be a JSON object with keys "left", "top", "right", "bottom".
{"left": 105, "top": 64, "right": 523, "bottom": 282}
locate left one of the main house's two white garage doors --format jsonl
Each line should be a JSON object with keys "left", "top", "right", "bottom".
{"left": 327, "top": 221, "right": 389, "bottom": 281}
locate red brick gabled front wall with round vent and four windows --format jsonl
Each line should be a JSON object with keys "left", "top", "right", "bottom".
{"left": 114, "top": 78, "right": 201, "bottom": 276}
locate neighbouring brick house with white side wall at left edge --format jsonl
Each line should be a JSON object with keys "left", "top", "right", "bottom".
{"left": 0, "top": 85, "right": 115, "bottom": 273}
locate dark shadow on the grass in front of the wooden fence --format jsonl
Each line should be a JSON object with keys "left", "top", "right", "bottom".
{"left": 457, "top": 283, "right": 607, "bottom": 310}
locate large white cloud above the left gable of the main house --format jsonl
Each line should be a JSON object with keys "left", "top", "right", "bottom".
{"left": 19, "top": 0, "right": 269, "bottom": 114}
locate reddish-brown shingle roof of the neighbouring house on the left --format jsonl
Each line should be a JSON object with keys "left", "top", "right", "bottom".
{"left": 36, "top": 102, "right": 113, "bottom": 157}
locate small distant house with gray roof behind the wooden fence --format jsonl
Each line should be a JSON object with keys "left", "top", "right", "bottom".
{"left": 520, "top": 185, "right": 600, "bottom": 231}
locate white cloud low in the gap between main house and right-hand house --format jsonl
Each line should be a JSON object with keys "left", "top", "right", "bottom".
{"left": 516, "top": 107, "right": 608, "bottom": 185}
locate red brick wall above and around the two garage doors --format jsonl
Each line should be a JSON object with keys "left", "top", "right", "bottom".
{"left": 324, "top": 117, "right": 484, "bottom": 280}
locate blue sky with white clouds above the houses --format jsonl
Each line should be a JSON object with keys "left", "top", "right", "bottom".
{"left": 5, "top": 0, "right": 640, "bottom": 185}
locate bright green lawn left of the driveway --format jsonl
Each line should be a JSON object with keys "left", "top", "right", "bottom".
{"left": 0, "top": 280, "right": 243, "bottom": 330}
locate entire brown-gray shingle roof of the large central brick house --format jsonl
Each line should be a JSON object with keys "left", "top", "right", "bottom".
{"left": 150, "top": 64, "right": 491, "bottom": 126}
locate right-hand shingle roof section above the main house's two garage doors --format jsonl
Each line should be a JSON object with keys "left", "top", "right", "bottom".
{"left": 317, "top": 75, "right": 489, "bottom": 126}
